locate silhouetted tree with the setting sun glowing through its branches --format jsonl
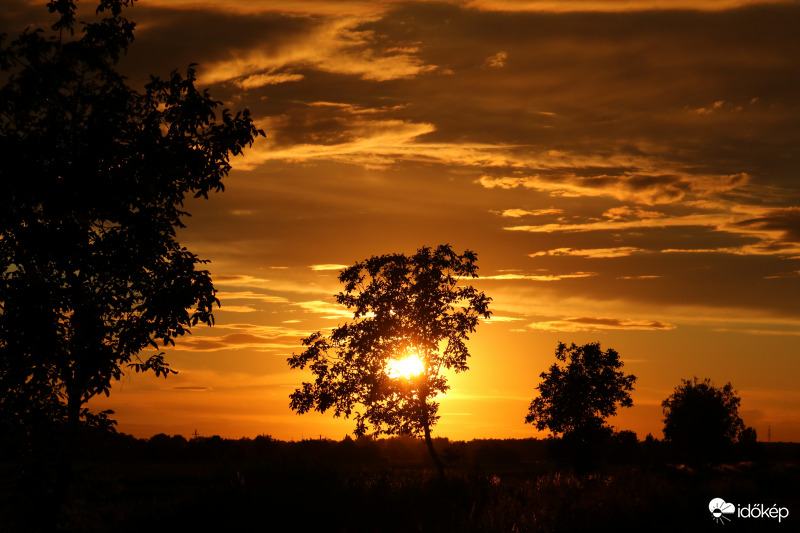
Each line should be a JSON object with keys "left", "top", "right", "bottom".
{"left": 288, "top": 245, "right": 491, "bottom": 473}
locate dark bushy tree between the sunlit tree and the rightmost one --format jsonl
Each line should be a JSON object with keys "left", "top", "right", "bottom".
{"left": 525, "top": 342, "right": 636, "bottom": 444}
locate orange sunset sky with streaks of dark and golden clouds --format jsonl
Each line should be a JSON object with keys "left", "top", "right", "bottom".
{"left": 5, "top": 0, "right": 800, "bottom": 442}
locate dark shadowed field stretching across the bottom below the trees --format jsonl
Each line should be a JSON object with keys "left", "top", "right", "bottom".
{"left": 0, "top": 435, "right": 800, "bottom": 532}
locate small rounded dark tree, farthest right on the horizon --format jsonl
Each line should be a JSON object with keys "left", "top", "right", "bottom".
{"left": 661, "top": 377, "right": 755, "bottom": 462}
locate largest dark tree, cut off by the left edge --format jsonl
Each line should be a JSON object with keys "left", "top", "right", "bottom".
{"left": 0, "top": 0, "right": 263, "bottom": 433}
